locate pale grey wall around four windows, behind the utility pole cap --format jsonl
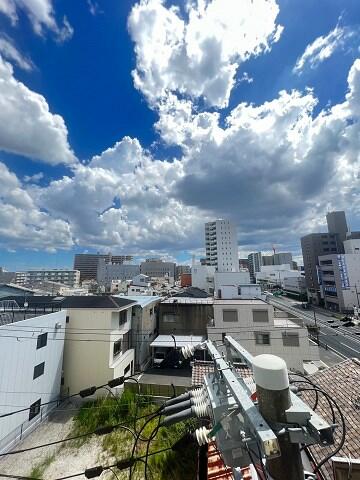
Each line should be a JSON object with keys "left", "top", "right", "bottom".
{"left": 208, "top": 300, "right": 319, "bottom": 371}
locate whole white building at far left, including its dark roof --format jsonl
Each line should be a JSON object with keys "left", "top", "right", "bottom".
{"left": 0, "top": 297, "right": 66, "bottom": 453}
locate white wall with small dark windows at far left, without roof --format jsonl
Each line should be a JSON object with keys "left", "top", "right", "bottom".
{"left": 0, "top": 310, "right": 66, "bottom": 452}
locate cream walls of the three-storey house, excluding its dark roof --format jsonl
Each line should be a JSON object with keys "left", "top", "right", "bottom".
{"left": 64, "top": 308, "right": 134, "bottom": 394}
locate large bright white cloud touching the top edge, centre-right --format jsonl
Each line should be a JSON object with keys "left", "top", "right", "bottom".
{"left": 128, "top": 0, "right": 282, "bottom": 107}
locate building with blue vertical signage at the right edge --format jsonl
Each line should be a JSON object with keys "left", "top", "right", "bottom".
{"left": 318, "top": 253, "right": 360, "bottom": 312}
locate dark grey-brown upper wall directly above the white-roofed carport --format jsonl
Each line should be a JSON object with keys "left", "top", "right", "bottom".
{"left": 159, "top": 303, "right": 214, "bottom": 335}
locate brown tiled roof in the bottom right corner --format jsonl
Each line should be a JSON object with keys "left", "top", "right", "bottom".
{"left": 299, "top": 359, "right": 360, "bottom": 479}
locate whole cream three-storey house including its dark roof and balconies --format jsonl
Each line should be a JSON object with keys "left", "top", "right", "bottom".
{"left": 62, "top": 295, "right": 135, "bottom": 395}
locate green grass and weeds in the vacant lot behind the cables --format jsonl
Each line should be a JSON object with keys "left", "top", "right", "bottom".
{"left": 71, "top": 389, "right": 197, "bottom": 480}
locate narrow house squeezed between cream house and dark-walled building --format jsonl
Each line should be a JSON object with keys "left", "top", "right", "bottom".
{"left": 120, "top": 295, "right": 161, "bottom": 371}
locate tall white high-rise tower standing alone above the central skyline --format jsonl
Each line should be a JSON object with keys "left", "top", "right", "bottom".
{"left": 205, "top": 220, "right": 239, "bottom": 272}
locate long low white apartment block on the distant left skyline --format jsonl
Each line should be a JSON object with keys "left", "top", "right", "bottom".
{"left": 15, "top": 270, "right": 80, "bottom": 287}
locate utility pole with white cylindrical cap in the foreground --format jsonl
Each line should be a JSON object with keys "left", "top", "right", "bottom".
{"left": 253, "top": 354, "right": 305, "bottom": 480}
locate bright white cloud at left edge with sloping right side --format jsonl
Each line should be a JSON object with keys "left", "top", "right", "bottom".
{"left": 0, "top": 56, "right": 76, "bottom": 165}
